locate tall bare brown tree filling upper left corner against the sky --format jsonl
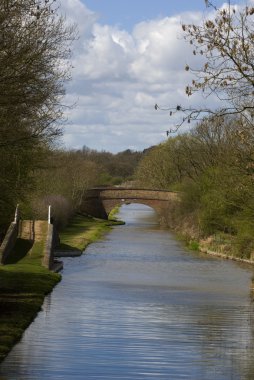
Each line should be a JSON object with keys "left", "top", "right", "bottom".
{"left": 0, "top": 0, "right": 76, "bottom": 148}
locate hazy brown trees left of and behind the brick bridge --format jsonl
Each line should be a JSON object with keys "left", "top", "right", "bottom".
{"left": 27, "top": 146, "right": 143, "bottom": 227}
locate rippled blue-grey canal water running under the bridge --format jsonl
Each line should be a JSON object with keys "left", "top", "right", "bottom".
{"left": 0, "top": 205, "right": 254, "bottom": 380}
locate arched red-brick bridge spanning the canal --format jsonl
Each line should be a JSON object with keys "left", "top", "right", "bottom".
{"left": 81, "top": 187, "right": 178, "bottom": 219}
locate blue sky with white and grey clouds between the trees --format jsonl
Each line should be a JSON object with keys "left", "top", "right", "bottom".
{"left": 61, "top": 0, "right": 238, "bottom": 152}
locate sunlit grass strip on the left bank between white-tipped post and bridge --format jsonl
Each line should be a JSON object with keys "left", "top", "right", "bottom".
{"left": 58, "top": 214, "right": 123, "bottom": 251}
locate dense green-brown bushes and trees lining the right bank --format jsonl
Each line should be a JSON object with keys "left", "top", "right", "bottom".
{"left": 136, "top": 118, "right": 254, "bottom": 258}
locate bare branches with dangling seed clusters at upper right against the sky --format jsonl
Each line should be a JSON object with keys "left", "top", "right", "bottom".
{"left": 155, "top": 1, "right": 254, "bottom": 129}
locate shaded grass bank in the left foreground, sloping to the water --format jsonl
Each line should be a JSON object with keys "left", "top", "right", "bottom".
{"left": 0, "top": 224, "right": 61, "bottom": 361}
